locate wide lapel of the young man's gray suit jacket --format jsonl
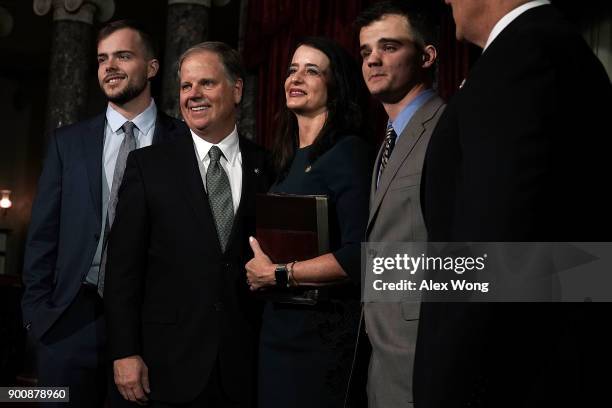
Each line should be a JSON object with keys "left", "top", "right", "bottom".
{"left": 367, "top": 96, "right": 443, "bottom": 230}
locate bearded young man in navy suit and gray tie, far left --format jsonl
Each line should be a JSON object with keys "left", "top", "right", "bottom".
{"left": 22, "top": 21, "right": 184, "bottom": 407}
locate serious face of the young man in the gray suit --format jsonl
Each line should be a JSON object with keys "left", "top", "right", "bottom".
{"left": 359, "top": 14, "right": 422, "bottom": 104}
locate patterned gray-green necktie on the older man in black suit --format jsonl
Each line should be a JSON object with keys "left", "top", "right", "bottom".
{"left": 206, "top": 146, "right": 234, "bottom": 252}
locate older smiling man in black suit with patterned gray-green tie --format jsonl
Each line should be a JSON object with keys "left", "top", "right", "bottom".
{"left": 104, "top": 42, "right": 268, "bottom": 407}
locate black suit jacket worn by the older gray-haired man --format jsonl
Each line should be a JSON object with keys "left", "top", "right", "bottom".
{"left": 104, "top": 132, "right": 269, "bottom": 406}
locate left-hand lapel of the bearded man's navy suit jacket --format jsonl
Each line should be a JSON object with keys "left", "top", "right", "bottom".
{"left": 81, "top": 114, "right": 106, "bottom": 223}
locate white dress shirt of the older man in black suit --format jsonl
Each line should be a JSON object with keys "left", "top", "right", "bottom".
{"left": 190, "top": 126, "right": 242, "bottom": 214}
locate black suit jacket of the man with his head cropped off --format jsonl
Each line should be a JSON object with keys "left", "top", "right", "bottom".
{"left": 415, "top": 6, "right": 612, "bottom": 408}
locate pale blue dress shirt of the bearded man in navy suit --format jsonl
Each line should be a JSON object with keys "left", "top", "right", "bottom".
{"left": 103, "top": 99, "right": 157, "bottom": 190}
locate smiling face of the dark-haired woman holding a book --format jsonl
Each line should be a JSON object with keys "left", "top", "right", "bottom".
{"left": 285, "top": 45, "right": 329, "bottom": 116}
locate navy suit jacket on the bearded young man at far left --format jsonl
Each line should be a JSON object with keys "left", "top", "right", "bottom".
{"left": 22, "top": 112, "right": 185, "bottom": 339}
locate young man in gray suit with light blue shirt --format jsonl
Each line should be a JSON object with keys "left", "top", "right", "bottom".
{"left": 357, "top": 1, "right": 444, "bottom": 408}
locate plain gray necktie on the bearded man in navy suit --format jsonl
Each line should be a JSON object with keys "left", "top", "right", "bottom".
{"left": 98, "top": 121, "right": 136, "bottom": 297}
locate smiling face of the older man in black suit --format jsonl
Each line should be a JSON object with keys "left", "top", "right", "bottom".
{"left": 179, "top": 50, "right": 242, "bottom": 143}
